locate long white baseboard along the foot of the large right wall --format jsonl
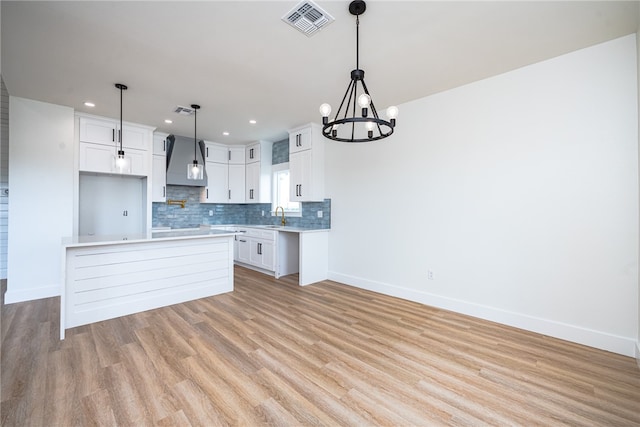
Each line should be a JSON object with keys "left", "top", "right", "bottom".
{"left": 329, "top": 271, "right": 640, "bottom": 364}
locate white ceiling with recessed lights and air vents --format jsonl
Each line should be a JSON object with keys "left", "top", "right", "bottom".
{"left": 1, "top": 0, "right": 638, "bottom": 144}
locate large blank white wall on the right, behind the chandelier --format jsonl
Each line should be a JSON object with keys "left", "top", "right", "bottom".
{"left": 325, "top": 35, "right": 639, "bottom": 355}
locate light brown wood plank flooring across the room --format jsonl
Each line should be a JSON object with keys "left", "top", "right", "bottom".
{"left": 0, "top": 267, "right": 640, "bottom": 426}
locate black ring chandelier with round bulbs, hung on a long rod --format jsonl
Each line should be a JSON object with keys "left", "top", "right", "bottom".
{"left": 320, "top": 0, "right": 398, "bottom": 142}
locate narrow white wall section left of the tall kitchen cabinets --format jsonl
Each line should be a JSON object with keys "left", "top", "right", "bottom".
{"left": 5, "top": 97, "right": 74, "bottom": 303}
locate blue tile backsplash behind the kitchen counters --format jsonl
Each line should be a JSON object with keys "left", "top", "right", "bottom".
{"left": 152, "top": 185, "right": 331, "bottom": 229}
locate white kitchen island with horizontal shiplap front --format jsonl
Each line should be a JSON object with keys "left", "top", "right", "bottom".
{"left": 60, "top": 230, "right": 233, "bottom": 339}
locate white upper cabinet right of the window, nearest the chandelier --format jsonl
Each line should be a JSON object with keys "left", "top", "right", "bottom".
{"left": 289, "top": 123, "right": 324, "bottom": 202}
